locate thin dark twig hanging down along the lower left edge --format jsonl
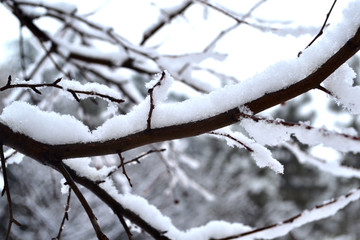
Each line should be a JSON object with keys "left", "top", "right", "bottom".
{"left": 0, "top": 144, "right": 21, "bottom": 240}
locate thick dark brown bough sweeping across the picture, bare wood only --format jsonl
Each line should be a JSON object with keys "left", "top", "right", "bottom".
{"left": 0, "top": 24, "right": 360, "bottom": 162}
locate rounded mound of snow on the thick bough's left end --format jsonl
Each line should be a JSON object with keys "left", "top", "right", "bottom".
{"left": 0, "top": 102, "right": 91, "bottom": 144}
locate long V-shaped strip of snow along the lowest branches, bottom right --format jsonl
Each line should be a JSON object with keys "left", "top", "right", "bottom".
{"left": 100, "top": 170, "right": 360, "bottom": 240}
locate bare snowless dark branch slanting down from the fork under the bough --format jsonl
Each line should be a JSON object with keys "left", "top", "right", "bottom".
{"left": 54, "top": 161, "right": 108, "bottom": 240}
